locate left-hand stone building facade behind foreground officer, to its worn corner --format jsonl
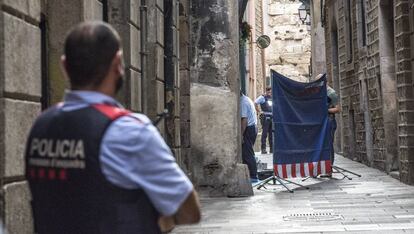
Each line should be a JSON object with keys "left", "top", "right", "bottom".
{"left": 0, "top": 0, "right": 252, "bottom": 234}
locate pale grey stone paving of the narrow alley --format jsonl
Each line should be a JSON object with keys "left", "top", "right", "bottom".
{"left": 174, "top": 156, "right": 414, "bottom": 233}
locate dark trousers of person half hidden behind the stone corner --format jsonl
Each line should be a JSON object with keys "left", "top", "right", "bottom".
{"left": 242, "top": 125, "right": 257, "bottom": 179}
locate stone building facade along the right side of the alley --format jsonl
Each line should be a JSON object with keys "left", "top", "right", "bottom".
{"left": 321, "top": 0, "right": 414, "bottom": 184}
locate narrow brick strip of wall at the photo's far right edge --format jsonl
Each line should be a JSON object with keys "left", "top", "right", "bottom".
{"left": 395, "top": 0, "right": 414, "bottom": 184}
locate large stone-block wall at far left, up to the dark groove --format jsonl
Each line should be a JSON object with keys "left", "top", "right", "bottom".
{"left": 0, "top": 0, "right": 42, "bottom": 233}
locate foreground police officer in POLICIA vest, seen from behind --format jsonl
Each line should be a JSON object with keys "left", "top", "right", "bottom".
{"left": 25, "top": 22, "right": 200, "bottom": 234}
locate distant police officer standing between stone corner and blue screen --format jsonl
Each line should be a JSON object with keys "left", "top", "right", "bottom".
{"left": 254, "top": 87, "right": 273, "bottom": 154}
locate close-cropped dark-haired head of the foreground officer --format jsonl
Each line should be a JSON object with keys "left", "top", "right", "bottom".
{"left": 64, "top": 21, "right": 121, "bottom": 89}
